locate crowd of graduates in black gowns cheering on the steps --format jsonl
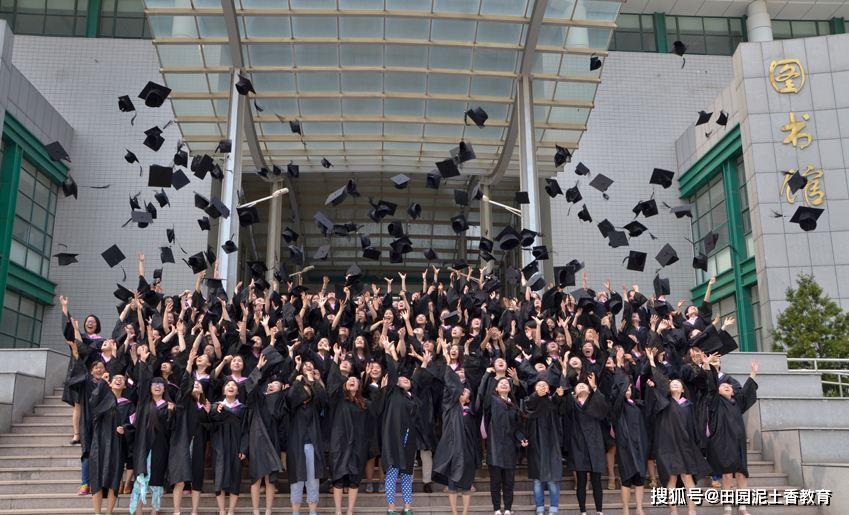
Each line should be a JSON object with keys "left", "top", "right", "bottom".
{"left": 60, "top": 255, "right": 757, "bottom": 515}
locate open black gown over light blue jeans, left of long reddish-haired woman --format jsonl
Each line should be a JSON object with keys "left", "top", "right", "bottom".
{"left": 286, "top": 381, "right": 327, "bottom": 483}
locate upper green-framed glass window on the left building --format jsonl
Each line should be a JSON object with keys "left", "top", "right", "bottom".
{"left": 10, "top": 161, "right": 59, "bottom": 277}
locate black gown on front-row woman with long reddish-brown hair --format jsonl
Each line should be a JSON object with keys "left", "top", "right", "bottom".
{"left": 327, "top": 363, "right": 371, "bottom": 485}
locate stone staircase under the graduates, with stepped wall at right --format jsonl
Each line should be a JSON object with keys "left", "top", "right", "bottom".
{"left": 0, "top": 354, "right": 836, "bottom": 515}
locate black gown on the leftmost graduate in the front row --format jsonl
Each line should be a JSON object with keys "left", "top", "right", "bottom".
{"left": 88, "top": 379, "right": 130, "bottom": 493}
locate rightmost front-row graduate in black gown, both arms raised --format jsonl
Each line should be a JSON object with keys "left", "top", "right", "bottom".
{"left": 705, "top": 354, "right": 758, "bottom": 515}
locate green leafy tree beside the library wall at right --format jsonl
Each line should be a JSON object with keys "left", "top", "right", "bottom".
{"left": 772, "top": 274, "right": 849, "bottom": 358}
